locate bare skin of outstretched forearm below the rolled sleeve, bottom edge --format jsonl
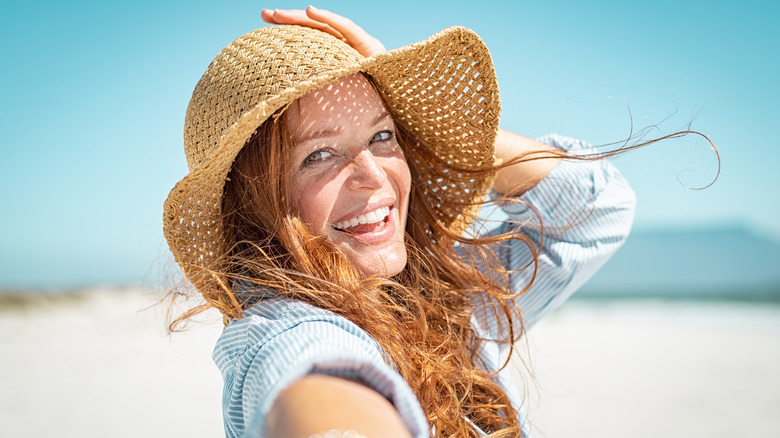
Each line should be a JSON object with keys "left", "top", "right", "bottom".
{"left": 264, "top": 374, "right": 411, "bottom": 438}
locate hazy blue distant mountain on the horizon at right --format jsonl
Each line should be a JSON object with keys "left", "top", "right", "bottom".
{"left": 578, "top": 227, "right": 780, "bottom": 301}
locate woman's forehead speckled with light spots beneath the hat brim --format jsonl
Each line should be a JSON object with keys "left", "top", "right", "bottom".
{"left": 288, "top": 73, "right": 387, "bottom": 139}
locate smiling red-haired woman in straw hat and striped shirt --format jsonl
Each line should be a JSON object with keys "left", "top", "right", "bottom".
{"left": 164, "top": 7, "right": 634, "bottom": 437}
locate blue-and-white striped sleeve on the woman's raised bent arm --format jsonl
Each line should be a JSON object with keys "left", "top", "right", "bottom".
{"left": 474, "top": 135, "right": 636, "bottom": 329}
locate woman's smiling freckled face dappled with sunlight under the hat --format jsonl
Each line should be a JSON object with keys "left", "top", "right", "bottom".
{"left": 287, "top": 73, "right": 411, "bottom": 277}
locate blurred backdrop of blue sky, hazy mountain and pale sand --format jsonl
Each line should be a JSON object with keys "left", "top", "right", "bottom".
{"left": 0, "top": 0, "right": 780, "bottom": 437}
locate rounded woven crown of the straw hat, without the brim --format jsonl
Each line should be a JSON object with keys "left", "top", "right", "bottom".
{"left": 184, "top": 26, "right": 364, "bottom": 170}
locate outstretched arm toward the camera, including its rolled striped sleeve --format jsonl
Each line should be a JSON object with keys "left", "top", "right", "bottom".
{"left": 214, "top": 297, "right": 430, "bottom": 438}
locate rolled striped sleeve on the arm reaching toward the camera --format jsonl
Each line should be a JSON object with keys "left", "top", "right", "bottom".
{"left": 214, "top": 298, "right": 429, "bottom": 437}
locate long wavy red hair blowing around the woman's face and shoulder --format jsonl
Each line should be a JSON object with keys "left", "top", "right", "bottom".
{"left": 166, "top": 88, "right": 536, "bottom": 437}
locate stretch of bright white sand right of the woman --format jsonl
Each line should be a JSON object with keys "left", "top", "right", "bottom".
{"left": 530, "top": 302, "right": 780, "bottom": 438}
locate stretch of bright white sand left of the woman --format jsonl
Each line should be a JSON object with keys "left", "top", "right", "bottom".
{"left": 0, "top": 292, "right": 224, "bottom": 438}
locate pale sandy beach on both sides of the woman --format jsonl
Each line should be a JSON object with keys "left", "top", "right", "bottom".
{"left": 0, "top": 290, "right": 780, "bottom": 438}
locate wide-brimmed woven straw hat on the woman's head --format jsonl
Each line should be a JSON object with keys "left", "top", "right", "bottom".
{"left": 163, "top": 26, "right": 500, "bottom": 294}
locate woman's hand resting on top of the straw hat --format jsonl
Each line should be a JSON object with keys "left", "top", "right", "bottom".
{"left": 260, "top": 6, "right": 386, "bottom": 58}
